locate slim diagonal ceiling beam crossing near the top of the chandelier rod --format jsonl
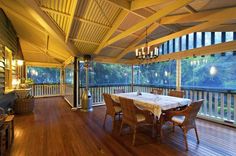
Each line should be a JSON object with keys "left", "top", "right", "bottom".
{"left": 114, "top": 23, "right": 160, "bottom": 62}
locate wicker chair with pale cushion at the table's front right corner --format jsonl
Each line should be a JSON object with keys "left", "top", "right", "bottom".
{"left": 165, "top": 100, "right": 203, "bottom": 150}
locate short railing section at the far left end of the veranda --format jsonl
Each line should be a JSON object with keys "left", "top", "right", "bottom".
{"left": 31, "top": 84, "right": 61, "bottom": 97}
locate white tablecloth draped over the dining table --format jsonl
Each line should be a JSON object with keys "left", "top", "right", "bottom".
{"left": 111, "top": 92, "right": 192, "bottom": 117}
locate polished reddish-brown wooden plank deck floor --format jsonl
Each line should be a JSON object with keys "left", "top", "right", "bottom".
{"left": 9, "top": 97, "right": 236, "bottom": 156}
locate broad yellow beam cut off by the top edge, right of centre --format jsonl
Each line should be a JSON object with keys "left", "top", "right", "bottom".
{"left": 130, "top": 0, "right": 170, "bottom": 10}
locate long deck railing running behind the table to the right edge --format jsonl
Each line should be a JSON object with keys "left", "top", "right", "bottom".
{"left": 80, "top": 84, "right": 236, "bottom": 125}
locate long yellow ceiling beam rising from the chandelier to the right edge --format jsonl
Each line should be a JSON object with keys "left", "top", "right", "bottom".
{"left": 134, "top": 8, "right": 236, "bottom": 49}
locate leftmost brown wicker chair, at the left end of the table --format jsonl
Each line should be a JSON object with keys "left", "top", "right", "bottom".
{"left": 103, "top": 93, "right": 121, "bottom": 129}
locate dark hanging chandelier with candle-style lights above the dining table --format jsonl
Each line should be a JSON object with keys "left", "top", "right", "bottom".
{"left": 135, "top": 27, "right": 158, "bottom": 60}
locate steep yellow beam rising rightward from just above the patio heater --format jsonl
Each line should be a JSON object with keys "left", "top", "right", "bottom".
{"left": 94, "top": 10, "right": 129, "bottom": 54}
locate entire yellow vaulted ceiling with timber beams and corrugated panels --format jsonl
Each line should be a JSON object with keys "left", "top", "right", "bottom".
{"left": 0, "top": 0, "right": 236, "bottom": 63}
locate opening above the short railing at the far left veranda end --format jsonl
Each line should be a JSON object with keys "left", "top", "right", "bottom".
{"left": 27, "top": 66, "right": 60, "bottom": 84}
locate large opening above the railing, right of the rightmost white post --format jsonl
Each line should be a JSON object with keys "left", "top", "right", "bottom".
{"left": 182, "top": 52, "right": 236, "bottom": 89}
